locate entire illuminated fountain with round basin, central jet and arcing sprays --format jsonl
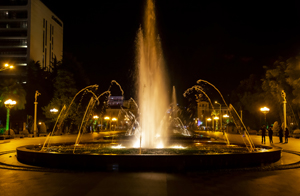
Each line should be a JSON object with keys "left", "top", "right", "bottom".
{"left": 17, "top": 0, "right": 281, "bottom": 170}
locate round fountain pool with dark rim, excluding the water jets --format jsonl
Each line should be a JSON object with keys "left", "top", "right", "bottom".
{"left": 17, "top": 142, "right": 281, "bottom": 171}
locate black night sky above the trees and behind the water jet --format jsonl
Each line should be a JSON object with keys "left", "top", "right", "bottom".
{"left": 42, "top": 0, "right": 300, "bottom": 102}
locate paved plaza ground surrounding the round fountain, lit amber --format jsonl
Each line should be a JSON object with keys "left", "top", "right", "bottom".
{"left": 0, "top": 133, "right": 300, "bottom": 196}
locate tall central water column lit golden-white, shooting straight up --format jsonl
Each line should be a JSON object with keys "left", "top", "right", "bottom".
{"left": 137, "top": 0, "right": 168, "bottom": 147}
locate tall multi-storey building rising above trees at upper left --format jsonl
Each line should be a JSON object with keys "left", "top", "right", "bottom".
{"left": 0, "top": 0, "right": 63, "bottom": 83}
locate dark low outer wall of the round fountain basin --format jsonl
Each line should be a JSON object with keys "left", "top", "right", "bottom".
{"left": 17, "top": 144, "right": 281, "bottom": 171}
